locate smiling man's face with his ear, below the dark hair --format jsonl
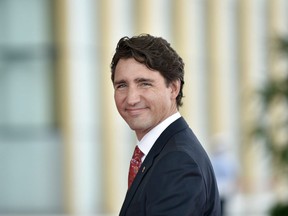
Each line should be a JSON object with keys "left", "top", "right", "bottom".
{"left": 113, "top": 58, "right": 180, "bottom": 140}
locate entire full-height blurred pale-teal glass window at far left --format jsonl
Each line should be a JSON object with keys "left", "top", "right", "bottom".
{"left": 0, "top": 0, "right": 63, "bottom": 215}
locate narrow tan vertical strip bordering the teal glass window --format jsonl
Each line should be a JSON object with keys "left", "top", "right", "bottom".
{"left": 53, "top": 0, "right": 73, "bottom": 213}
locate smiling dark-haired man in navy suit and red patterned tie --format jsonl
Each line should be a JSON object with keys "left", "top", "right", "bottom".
{"left": 111, "top": 34, "right": 220, "bottom": 216}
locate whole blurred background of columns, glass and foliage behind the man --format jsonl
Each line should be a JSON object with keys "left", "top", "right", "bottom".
{"left": 0, "top": 0, "right": 288, "bottom": 216}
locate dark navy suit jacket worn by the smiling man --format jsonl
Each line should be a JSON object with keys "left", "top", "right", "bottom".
{"left": 120, "top": 117, "right": 220, "bottom": 216}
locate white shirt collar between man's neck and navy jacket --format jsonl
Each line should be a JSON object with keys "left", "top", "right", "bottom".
{"left": 137, "top": 112, "right": 181, "bottom": 161}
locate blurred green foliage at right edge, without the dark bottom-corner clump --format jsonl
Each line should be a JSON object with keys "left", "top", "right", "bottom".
{"left": 253, "top": 37, "right": 288, "bottom": 167}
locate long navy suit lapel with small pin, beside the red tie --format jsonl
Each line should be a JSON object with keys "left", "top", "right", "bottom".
{"left": 119, "top": 117, "right": 188, "bottom": 216}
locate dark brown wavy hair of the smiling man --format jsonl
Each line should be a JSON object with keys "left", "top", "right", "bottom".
{"left": 110, "top": 34, "right": 184, "bottom": 107}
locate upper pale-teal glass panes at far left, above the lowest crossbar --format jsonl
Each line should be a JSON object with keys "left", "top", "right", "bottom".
{"left": 0, "top": 0, "right": 55, "bottom": 131}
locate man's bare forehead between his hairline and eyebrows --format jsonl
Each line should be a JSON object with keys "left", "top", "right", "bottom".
{"left": 114, "top": 58, "right": 164, "bottom": 81}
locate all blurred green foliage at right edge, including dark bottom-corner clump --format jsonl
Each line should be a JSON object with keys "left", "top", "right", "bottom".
{"left": 252, "top": 37, "right": 288, "bottom": 216}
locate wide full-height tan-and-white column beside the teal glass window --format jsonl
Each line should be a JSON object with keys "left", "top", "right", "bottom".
{"left": 55, "top": 0, "right": 102, "bottom": 214}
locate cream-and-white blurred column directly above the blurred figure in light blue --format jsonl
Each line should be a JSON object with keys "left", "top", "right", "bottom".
{"left": 206, "top": 0, "right": 239, "bottom": 147}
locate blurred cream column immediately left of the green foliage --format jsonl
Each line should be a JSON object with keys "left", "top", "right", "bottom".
{"left": 238, "top": 0, "right": 267, "bottom": 193}
